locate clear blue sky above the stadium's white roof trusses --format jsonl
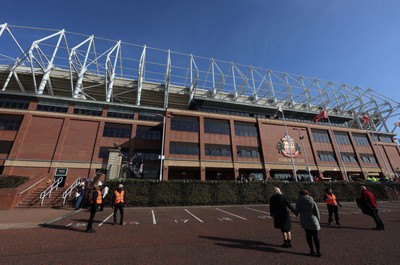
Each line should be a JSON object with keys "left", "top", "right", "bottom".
{"left": 0, "top": 0, "right": 400, "bottom": 130}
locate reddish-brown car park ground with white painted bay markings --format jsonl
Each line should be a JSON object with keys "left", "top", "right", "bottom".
{"left": 0, "top": 202, "right": 400, "bottom": 265}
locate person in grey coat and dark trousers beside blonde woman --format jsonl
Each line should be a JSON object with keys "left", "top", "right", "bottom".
{"left": 295, "top": 190, "right": 321, "bottom": 257}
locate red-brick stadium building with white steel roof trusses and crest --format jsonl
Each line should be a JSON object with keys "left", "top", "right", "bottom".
{"left": 0, "top": 24, "right": 400, "bottom": 193}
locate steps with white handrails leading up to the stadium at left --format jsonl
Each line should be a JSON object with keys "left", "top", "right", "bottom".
{"left": 15, "top": 188, "right": 75, "bottom": 208}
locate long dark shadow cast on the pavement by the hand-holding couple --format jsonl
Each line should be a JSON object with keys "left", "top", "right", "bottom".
{"left": 199, "top": 236, "right": 308, "bottom": 256}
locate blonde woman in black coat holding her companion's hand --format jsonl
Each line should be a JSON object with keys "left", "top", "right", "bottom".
{"left": 269, "top": 187, "right": 295, "bottom": 248}
